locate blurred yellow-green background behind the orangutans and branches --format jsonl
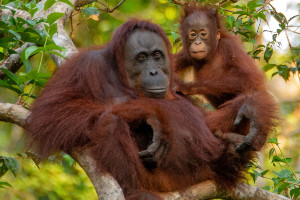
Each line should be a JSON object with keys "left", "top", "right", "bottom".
{"left": 0, "top": 0, "right": 300, "bottom": 200}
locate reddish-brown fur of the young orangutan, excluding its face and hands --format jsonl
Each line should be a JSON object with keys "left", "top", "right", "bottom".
{"left": 175, "top": 4, "right": 276, "bottom": 150}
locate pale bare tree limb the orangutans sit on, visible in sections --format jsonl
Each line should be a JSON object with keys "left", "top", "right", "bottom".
{"left": 0, "top": 103, "right": 288, "bottom": 200}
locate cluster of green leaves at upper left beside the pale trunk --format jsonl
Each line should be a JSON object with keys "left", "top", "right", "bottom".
{"left": 0, "top": 0, "right": 67, "bottom": 98}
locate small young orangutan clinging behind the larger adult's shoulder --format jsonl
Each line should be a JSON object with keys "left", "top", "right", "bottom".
{"left": 175, "top": 4, "right": 276, "bottom": 153}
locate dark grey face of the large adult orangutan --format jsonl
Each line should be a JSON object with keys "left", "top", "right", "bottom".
{"left": 124, "top": 30, "right": 170, "bottom": 99}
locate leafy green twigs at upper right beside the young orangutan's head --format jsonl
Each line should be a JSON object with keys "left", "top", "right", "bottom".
{"left": 220, "top": 0, "right": 300, "bottom": 80}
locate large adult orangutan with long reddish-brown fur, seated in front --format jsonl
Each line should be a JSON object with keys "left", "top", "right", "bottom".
{"left": 26, "top": 20, "right": 248, "bottom": 200}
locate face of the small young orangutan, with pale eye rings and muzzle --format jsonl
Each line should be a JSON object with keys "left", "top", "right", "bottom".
{"left": 184, "top": 12, "right": 220, "bottom": 60}
